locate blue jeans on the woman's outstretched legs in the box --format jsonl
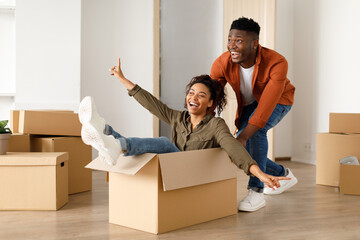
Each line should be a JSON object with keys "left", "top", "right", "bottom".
{"left": 104, "top": 124, "right": 180, "bottom": 156}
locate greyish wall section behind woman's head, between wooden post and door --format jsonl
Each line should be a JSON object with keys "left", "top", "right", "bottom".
{"left": 160, "top": 0, "right": 223, "bottom": 137}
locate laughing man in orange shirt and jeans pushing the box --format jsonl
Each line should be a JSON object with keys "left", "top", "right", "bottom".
{"left": 210, "top": 17, "right": 297, "bottom": 211}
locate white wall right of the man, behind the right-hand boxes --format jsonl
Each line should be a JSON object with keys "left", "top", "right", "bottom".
{"left": 292, "top": 0, "right": 360, "bottom": 164}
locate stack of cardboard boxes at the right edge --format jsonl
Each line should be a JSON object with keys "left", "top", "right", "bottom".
{"left": 316, "top": 113, "right": 360, "bottom": 195}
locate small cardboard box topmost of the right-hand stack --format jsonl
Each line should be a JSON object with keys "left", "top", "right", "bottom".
{"left": 329, "top": 113, "right": 360, "bottom": 134}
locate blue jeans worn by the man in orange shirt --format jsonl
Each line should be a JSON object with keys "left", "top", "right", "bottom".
{"left": 236, "top": 101, "right": 292, "bottom": 192}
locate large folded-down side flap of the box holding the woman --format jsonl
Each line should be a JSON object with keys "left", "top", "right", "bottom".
{"left": 158, "top": 148, "right": 238, "bottom": 191}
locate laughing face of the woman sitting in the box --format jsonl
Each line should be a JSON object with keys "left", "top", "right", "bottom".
{"left": 186, "top": 83, "right": 213, "bottom": 116}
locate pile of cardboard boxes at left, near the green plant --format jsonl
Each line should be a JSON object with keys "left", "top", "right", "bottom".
{"left": 0, "top": 110, "right": 92, "bottom": 210}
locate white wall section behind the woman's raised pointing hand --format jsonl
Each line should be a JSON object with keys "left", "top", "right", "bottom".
{"left": 81, "top": 0, "right": 154, "bottom": 137}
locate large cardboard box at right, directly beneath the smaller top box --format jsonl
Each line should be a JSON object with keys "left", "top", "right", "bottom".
{"left": 316, "top": 133, "right": 360, "bottom": 187}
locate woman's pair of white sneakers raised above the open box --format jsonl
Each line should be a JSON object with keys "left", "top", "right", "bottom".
{"left": 79, "top": 96, "right": 121, "bottom": 165}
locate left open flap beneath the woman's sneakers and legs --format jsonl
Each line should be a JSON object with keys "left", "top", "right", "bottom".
{"left": 85, "top": 153, "right": 156, "bottom": 175}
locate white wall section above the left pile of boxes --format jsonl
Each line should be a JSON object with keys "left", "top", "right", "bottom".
{"left": 15, "top": 0, "right": 81, "bottom": 110}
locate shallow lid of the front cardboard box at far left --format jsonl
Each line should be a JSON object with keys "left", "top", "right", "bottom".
{"left": 0, "top": 152, "right": 69, "bottom": 166}
